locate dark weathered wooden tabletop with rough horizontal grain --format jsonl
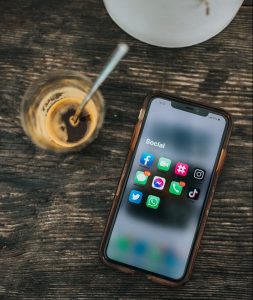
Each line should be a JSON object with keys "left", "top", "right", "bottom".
{"left": 0, "top": 0, "right": 252, "bottom": 300}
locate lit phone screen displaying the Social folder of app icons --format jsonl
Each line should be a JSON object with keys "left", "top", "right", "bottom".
{"left": 107, "top": 98, "right": 226, "bottom": 279}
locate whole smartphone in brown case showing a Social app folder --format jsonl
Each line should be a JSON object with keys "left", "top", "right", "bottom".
{"left": 99, "top": 92, "right": 232, "bottom": 286}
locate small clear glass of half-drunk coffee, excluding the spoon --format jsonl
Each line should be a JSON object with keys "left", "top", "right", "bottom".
{"left": 21, "top": 71, "right": 104, "bottom": 152}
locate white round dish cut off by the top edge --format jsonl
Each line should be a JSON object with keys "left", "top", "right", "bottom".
{"left": 104, "top": 0, "right": 243, "bottom": 48}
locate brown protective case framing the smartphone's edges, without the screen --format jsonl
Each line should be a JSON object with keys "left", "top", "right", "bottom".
{"left": 99, "top": 91, "right": 232, "bottom": 287}
